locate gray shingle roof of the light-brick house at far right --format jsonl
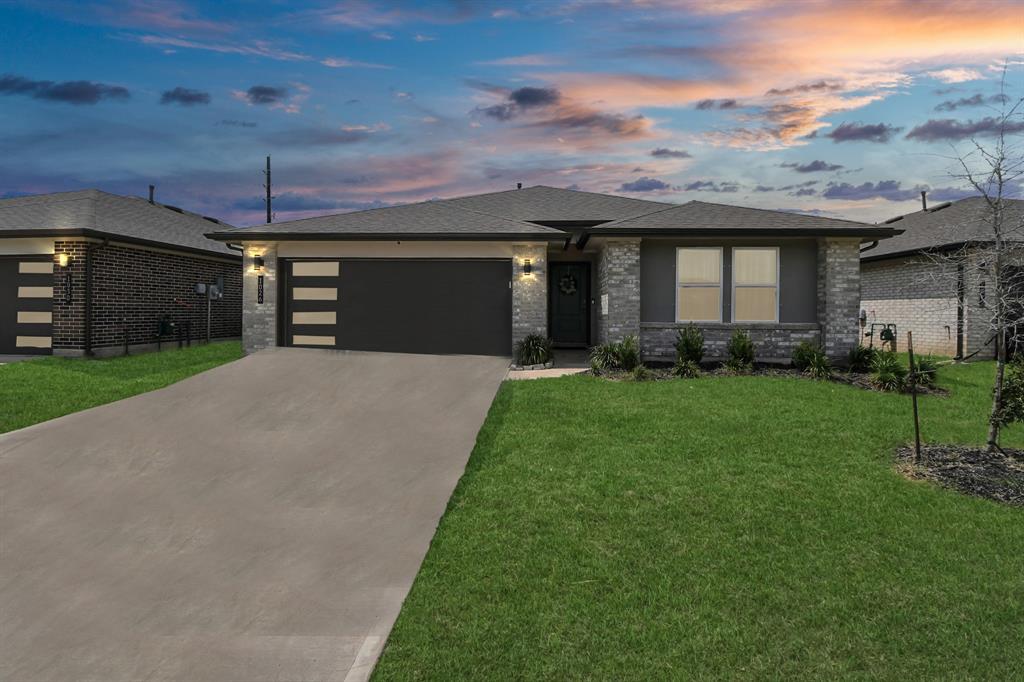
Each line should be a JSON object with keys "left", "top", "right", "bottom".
{"left": 862, "top": 197, "right": 1024, "bottom": 260}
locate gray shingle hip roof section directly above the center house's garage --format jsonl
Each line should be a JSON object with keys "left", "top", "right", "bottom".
{"left": 218, "top": 196, "right": 565, "bottom": 239}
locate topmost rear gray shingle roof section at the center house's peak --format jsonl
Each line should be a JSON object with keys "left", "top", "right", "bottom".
{"left": 447, "top": 184, "right": 673, "bottom": 222}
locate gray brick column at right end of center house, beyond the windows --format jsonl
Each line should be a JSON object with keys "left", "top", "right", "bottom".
{"left": 818, "top": 238, "right": 860, "bottom": 364}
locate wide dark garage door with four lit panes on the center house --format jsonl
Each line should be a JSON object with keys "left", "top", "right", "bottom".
{"left": 285, "top": 259, "right": 512, "bottom": 355}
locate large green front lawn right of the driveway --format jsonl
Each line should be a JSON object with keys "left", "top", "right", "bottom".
{"left": 374, "top": 364, "right": 1024, "bottom": 682}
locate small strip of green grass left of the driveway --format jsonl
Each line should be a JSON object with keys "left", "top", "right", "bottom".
{"left": 0, "top": 341, "right": 242, "bottom": 433}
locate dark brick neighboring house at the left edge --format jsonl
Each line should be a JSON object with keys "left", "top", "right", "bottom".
{"left": 0, "top": 189, "right": 242, "bottom": 355}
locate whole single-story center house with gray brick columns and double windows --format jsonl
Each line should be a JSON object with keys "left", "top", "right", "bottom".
{"left": 210, "top": 180, "right": 896, "bottom": 359}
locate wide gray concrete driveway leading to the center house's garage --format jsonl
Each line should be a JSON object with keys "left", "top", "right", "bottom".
{"left": 0, "top": 349, "right": 508, "bottom": 682}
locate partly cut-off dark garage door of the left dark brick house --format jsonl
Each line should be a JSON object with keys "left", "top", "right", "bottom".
{"left": 0, "top": 256, "right": 53, "bottom": 355}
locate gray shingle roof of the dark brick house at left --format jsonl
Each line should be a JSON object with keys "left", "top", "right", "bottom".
{"left": 0, "top": 189, "right": 240, "bottom": 257}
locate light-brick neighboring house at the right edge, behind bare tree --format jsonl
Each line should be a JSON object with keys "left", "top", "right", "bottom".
{"left": 860, "top": 197, "right": 1024, "bottom": 357}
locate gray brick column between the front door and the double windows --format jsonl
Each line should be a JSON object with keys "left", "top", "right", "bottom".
{"left": 597, "top": 239, "right": 640, "bottom": 343}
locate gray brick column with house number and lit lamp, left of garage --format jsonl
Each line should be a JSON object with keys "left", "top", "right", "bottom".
{"left": 242, "top": 242, "right": 278, "bottom": 353}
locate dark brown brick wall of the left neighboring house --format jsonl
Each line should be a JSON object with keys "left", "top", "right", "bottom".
{"left": 53, "top": 241, "right": 242, "bottom": 350}
